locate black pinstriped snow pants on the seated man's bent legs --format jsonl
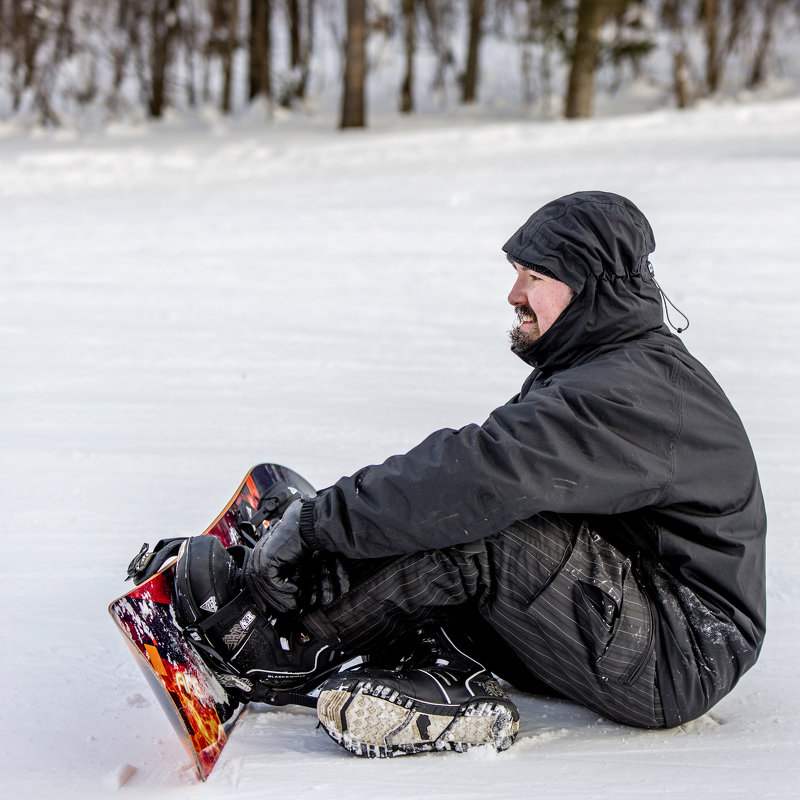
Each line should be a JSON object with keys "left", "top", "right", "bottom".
{"left": 303, "top": 514, "right": 665, "bottom": 728}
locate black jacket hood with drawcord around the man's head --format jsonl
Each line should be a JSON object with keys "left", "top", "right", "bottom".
{"left": 503, "top": 191, "right": 665, "bottom": 371}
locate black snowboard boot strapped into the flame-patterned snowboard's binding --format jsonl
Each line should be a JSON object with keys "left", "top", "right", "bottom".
{"left": 173, "top": 536, "right": 345, "bottom": 704}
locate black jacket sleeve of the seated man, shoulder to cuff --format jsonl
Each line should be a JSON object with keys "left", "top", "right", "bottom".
{"left": 302, "top": 360, "right": 679, "bottom": 558}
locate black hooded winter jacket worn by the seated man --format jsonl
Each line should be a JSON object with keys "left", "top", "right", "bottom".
{"left": 301, "top": 192, "right": 766, "bottom": 725}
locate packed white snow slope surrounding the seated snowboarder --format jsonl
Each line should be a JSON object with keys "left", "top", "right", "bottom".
{"left": 0, "top": 100, "right": 800, "bottom": 800}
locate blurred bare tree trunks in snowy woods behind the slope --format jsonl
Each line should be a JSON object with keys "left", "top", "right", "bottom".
{"left": 0, "top": 0, "right": 800, "bottom": 128}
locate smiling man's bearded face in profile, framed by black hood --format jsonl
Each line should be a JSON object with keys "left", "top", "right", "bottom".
{"left": 508, "top": 264, "right": 573, "bottom": 349}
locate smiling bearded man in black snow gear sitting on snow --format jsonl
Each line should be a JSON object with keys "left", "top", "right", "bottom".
{"left": 176, "top": 192, "right": 766, "bottom": 756}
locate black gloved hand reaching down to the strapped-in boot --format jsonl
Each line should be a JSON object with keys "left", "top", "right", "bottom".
{"left": 244, "top": 500, "right": 312, "bottom": 614}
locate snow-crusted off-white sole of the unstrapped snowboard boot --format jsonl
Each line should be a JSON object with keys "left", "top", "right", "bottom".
{"left": 317, "top": 681, "right": 519, "bottom": 758}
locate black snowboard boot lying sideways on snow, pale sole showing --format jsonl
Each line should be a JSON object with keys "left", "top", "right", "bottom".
{"left": 317, "top": 627, "right": 519, "bottom": 758}
